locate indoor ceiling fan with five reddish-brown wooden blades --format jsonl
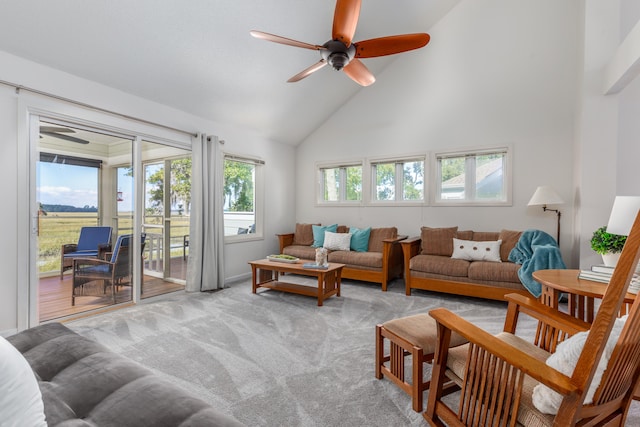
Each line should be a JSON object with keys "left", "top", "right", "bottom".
{"left": 250, "top": 0, "right": 430, "bottom": 86}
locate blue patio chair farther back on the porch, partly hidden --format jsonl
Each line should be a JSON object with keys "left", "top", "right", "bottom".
{"left": 60, "top": 226, "right": 112, "bottom": 280}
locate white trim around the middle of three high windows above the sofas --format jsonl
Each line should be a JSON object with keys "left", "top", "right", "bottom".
{"left": 363, "top": 153, "right": 430, "bottom": 206}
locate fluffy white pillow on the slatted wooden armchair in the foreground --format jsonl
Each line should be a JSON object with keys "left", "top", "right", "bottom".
{"left": 532, "top": 316, "right": 627, "bottom": 415}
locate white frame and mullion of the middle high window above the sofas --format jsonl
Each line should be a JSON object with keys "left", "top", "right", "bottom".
{"left": 368, "top": 154, "right": 429, "bottom": 206}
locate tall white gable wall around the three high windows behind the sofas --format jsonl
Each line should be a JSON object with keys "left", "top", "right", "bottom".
{"left": 296, "top": 0, "right": 581, "bottom": 259}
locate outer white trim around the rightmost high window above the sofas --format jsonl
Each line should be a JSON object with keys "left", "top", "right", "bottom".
{"left": 429, "top": 145, "right": 513, "bottom": 206}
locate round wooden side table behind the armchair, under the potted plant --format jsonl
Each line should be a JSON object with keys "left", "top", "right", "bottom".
{"left": 533, "top": 270, "right": 636, "bottom": 323}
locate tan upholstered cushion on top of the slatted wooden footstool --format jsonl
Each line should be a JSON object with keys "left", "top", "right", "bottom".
{"left": 382, "top": 313, "right": 467, "bottom": 354}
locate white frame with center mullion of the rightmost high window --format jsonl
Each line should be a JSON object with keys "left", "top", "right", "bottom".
{"left": 431, "top": 145, "right": 513, "bottom": 206}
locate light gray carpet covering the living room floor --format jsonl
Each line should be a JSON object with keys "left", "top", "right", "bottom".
{"left": 68, "top": 276, "right": 640, "bottom": 427}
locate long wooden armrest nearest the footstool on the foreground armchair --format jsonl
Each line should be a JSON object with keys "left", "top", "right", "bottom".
{"left": 429, "top": 308, "right": 578, "bottom": 395}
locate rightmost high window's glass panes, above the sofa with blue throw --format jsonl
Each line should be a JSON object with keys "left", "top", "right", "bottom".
{"left": 435, "top": 147, "right": 511, "bottom": 205}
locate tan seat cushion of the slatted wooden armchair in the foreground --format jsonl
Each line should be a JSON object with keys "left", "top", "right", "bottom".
{"left": 447, "top": 332, "right": 553, "bottom": 426}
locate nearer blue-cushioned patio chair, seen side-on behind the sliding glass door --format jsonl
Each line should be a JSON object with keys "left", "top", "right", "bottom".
{"left": 71, "top": 233, "right": 146, "bottom": 306}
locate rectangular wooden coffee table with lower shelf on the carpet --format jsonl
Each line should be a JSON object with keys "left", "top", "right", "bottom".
{"left": 249, "top": 259, "right": 344, "bottom": 307}
